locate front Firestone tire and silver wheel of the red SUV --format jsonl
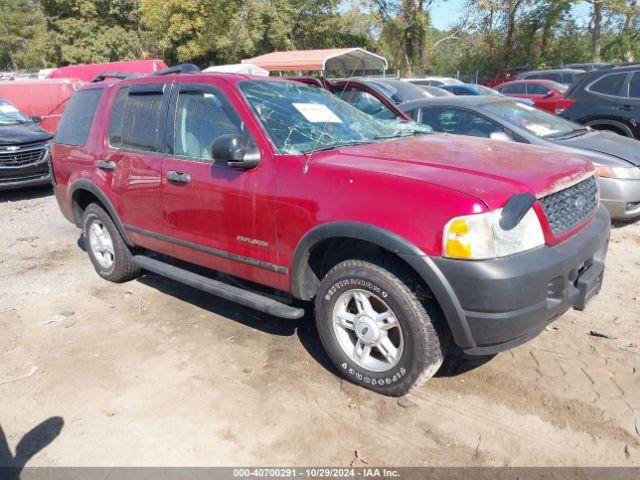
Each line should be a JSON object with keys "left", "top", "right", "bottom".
{"left": 315, "top": 257, "right": 449, "bottom": 396}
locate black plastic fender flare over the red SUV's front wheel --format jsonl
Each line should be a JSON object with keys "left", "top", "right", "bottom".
{"left": 291, "top": 222, "right": 475, "bottom": 348}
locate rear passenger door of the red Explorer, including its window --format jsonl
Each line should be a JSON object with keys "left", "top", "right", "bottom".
{"left": 103, "top": 83, "right": 170, "bottom": 253}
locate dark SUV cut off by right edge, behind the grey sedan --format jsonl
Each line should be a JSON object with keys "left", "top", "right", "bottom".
{"left": 562, "top": 64, "right": 640, "bottom": 139}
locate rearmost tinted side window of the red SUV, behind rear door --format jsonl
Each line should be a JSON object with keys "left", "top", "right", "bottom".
{"left": 55, "top": 88, "right": 103, "bottom": 147}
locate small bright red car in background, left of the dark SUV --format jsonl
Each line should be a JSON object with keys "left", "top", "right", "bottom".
{"left": 495, "top": 80, "right": 573, "bottom": 115}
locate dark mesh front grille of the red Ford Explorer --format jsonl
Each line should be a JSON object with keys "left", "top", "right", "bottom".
{"left": 540, "top": 176, "right": 598, "bottom": 235}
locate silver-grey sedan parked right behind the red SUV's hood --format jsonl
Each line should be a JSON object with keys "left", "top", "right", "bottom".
{"left": 399, "top": 96, "right": 640, "bottom": 220}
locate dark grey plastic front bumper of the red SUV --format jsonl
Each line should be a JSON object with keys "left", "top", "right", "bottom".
{"left": 433, "top": 206, "right": 611, "bottom": 355}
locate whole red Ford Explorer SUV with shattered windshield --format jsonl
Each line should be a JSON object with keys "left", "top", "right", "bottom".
{"left": 53, "top": 66, "right": 609, "bottom": 395}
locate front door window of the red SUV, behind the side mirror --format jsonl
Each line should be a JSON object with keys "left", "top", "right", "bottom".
{"left": 174, "top": 91, "right": 243, "bottom": 161}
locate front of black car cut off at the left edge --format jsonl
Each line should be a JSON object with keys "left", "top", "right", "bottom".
{"left": 0, "top": 99, "right": 52, "bottom": 190}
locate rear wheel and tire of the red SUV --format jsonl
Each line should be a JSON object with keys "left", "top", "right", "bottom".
{"left": 82, "top": 203, "right": 141, "bottom": 283}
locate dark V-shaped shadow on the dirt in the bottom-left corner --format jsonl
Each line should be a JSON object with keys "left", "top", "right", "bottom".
{"left": 0, "top": 417, "right": 64, "bottom": 480}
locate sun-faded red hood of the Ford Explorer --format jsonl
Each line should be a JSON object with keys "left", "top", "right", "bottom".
{"left": 321, "top": 134, "right": 593, "bottom": 210}
